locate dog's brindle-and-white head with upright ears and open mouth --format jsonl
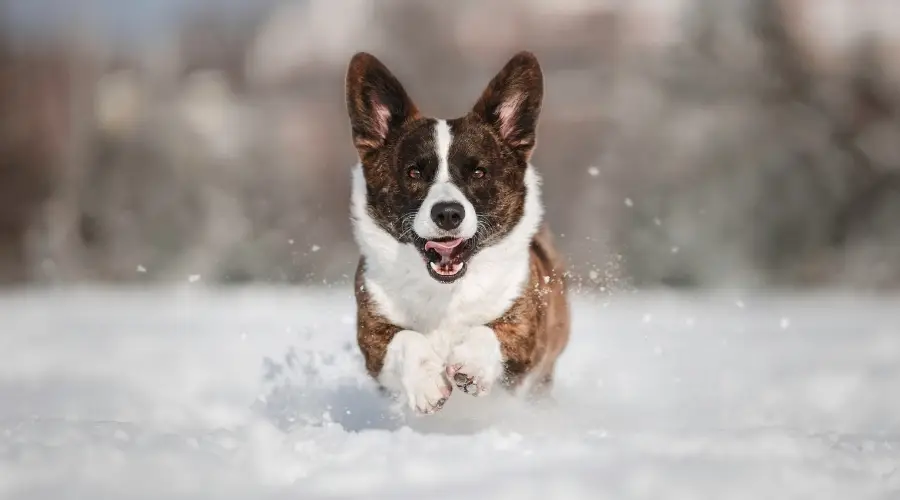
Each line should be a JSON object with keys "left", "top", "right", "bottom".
{"left": 346, "top": 52, "right": 543, "bottom": 283}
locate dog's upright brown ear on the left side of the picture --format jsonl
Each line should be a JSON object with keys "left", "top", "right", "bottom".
{"left": 346, "top": 52, "right": 419, "bottom": 159}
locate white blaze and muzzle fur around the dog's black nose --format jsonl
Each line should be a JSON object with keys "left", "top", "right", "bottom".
{"left": 413, "top": 120, "right": 478, "bottom": 240}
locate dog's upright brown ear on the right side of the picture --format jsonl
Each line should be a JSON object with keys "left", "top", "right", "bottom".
{"left": 472, "top": 51, "right": 544, "bottom": 161}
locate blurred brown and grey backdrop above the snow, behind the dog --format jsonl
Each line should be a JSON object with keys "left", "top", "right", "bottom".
{"left": 0, "top": 0, "right": 900, "bottom": 291}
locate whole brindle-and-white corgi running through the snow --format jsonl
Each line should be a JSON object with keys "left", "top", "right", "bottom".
{"left": 345, "top": 52, "right": 570, "bottom": 414}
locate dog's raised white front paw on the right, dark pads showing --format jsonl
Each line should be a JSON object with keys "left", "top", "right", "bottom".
{"left": 447, "top": 326, "right": 503, "bottom": 396}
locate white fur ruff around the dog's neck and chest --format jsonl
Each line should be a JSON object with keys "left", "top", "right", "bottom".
{"left": 351, "top": 164, "right": 544, "bottom": 333}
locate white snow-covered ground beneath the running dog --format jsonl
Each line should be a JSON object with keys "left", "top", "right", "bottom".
{"left": 0, "top": 289, "right": 900, "bottom": 500}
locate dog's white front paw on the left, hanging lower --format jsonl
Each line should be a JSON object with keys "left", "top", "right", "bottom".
{"left": 384, "top": 330, "right": 453, "bottom": 415}
